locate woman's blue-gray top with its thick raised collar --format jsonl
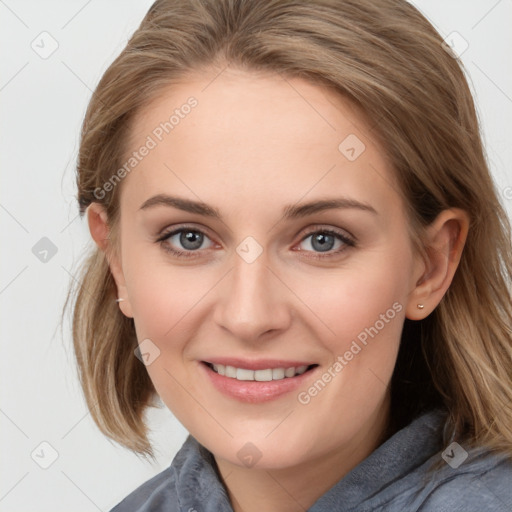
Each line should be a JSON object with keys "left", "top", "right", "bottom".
{"left": 111, "top": 410, "right": 512, "bottom": 512}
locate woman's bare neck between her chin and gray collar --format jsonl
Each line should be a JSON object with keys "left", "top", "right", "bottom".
{"left": 215, "top": 401, "right": 389, "bottom": 512}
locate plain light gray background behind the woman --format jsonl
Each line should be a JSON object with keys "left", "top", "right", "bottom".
{"left": 0, "top": 0, "right": 512, "bottom": 512}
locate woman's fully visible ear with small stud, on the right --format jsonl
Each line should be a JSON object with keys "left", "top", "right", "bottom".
{"left": 406, "top": 208, "right": 469, "bottom": 320}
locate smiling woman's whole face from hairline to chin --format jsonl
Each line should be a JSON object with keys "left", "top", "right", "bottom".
{"left": 106, "top": 69, "right": 417, "bottom": 468}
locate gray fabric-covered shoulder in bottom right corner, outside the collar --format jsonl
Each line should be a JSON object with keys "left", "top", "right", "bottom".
{"left": 419, "top": 445, "right": 512, "bottom": 512}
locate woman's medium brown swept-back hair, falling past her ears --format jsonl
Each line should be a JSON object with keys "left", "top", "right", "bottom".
{"left": 69, "top": 0, "right": 512, "bottom": 456}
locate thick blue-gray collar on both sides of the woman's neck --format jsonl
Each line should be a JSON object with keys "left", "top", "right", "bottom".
{"left": 171, "top": 410, "right": 446, "bottom": 512}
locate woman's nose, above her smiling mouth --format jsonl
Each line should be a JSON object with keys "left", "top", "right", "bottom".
{"left": 214, "top": 248, "right": 292, "bottom": 343}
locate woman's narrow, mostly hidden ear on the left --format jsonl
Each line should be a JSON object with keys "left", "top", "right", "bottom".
{"left": 87, "top": 203, "right": 133, "bottom": 318}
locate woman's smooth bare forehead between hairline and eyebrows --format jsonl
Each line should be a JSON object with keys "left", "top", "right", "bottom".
{"left": 121, "top": 69, "right": 398, "bottom": 220}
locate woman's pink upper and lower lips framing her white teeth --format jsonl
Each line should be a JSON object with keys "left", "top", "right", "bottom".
{"left": 199, "top": 359, "right": 319, "bottom": 404}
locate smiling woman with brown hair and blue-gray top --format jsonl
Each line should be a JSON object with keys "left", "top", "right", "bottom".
{"left": 68, "top": 0, "right": 512, "bottom": 512}
